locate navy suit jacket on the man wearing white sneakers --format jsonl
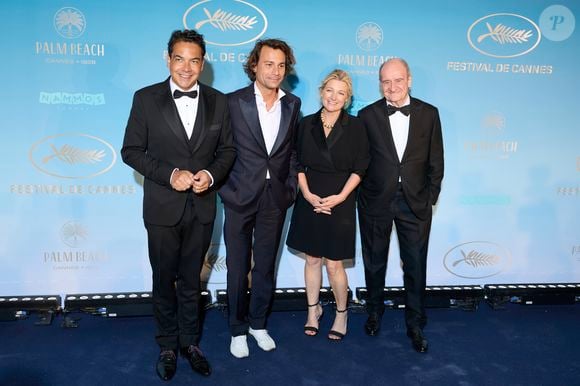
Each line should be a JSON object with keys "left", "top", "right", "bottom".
{"left": 219, "top": 83, "right": 301, "bottom": 213}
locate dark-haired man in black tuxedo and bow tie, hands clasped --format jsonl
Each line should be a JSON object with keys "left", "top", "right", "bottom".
{"left": 121, "top": 30, "right": 236, "bottom": 380}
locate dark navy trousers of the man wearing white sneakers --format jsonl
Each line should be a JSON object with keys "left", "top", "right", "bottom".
{"left": 224, "top": 182, "right": 286, "bottom": 336}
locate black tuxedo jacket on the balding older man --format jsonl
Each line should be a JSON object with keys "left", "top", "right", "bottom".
{"left": 358, "top": 98, "right": 443, "bottom": 220}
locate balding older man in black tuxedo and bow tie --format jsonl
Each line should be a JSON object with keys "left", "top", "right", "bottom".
{"left": 358, "top": 58, "right": 443, "bottom": 352}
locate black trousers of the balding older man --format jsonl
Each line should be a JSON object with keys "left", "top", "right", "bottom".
{"left": 359, "top": 188, "right": 431, "bottom": 328}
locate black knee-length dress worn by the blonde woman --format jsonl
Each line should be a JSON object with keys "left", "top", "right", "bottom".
{"left": 286, "top": 111, "right": 369, "bottom": 260}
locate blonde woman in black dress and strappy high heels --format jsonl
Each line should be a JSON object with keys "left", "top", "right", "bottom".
{"left": 286, "top": 70, "right": 369, "bottom": 340}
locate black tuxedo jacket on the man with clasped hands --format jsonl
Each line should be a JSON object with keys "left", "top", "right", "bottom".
{"left": 121, "top": 78, "right": 236, "bottom": 226}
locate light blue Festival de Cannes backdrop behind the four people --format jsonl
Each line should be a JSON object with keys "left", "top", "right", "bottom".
{"left": 0, "top": 0, "right": 580, "bottom": 295}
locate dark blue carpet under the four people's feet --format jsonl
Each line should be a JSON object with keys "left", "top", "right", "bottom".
{"left": 0, "top": 303, "right": 580, "bottom": 386}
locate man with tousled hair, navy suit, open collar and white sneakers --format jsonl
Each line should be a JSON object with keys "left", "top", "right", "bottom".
{"left": 219, "top": 39, "right": 301, "bottom": 358}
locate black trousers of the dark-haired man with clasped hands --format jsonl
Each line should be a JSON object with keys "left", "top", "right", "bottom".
{"left": 145, "top": 199, "right": 213, "bottom": 350}
